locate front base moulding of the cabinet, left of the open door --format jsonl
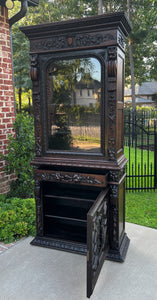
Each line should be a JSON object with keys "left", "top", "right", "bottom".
{"left": 30, "top": 236, "right": 87, "bottom": 255}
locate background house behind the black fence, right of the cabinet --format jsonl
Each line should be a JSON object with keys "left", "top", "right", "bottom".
{"left": 124, "top": 81, "right": 157, "bottom": 107}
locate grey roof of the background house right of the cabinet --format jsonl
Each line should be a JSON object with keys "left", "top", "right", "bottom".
{"left": 124, "top": 81, "right": 157, "bottom": 96}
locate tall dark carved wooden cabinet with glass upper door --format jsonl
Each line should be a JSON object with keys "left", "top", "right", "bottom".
{"left": 21, "top": 12, "right": 131, "bottom": 297}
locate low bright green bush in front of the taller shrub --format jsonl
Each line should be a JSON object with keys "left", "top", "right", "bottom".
{"left": 0, "top": 196, "right": 35, "bottom": 243}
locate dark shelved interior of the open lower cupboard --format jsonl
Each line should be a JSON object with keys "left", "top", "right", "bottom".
{"left": 43, "top": 183, "right": 100, "bottom": 244}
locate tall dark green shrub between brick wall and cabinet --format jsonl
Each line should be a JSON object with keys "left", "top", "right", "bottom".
{"left": 1, "top": 114, "right": 35, "bottom": 198}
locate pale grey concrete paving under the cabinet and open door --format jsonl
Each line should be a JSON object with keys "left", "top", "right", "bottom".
{"left": 0, "top": 223, "right": 157, "bottom": 300}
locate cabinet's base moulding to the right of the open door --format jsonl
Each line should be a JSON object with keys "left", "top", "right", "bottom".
{"left": 106, "top": 233, "right": 130, "bottom": 262}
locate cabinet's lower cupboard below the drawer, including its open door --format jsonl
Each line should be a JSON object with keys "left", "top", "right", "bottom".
{"left": 31, "top": 178, "right": 129, "bottom": 298}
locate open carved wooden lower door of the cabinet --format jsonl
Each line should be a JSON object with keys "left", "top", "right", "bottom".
{"left": 87, "top": 189, "right": 108, "bottom": 298}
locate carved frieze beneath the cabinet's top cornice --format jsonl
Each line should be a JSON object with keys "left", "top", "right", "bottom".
{"left": 31, "top": 32, "right": 116, "bottom": 52}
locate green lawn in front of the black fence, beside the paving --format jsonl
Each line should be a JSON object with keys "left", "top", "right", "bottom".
{"left": 126, "top": 192, "right": 157, "bottom": 229}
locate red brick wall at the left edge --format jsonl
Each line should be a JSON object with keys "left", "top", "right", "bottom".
{"left": 0, "top": 6, "right": 15, "bottom": 194}
